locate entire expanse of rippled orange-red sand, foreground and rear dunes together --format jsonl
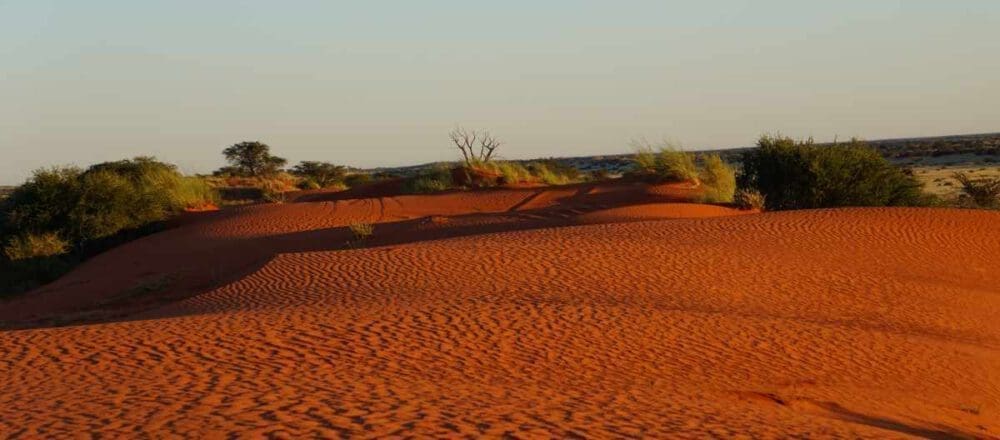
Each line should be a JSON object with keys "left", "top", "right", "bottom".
{"left": 0, "top": 181, "right": 1000, "bottom": 438}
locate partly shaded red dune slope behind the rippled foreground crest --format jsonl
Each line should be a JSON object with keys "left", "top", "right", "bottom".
{"left": 0, "top": 182, "right": 746, "bottom": 328}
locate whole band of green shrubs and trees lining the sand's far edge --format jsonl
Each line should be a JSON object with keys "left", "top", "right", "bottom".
{"left": 0, "top": 128, "right": 1000, "bottom": 295}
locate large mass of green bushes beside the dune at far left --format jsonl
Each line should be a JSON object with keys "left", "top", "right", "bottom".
{"left": 0, "top": 157, "right": 217, "bottom": 293}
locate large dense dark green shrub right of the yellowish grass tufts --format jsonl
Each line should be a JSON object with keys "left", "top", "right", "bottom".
{"left": 739, "top": 136, "right": 930, "bottom": 210}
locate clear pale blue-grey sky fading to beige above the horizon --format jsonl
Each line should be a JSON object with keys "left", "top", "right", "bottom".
{"left": 0, "top": 0, "right": 1000, "bottom": 183}
